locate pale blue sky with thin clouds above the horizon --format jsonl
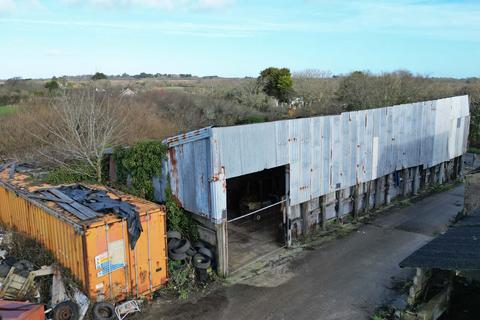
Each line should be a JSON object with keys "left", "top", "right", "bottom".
{"left": 0, "top": 0, "right": 480, "bottom": 78}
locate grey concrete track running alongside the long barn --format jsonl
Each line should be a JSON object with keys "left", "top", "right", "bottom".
{"left": 147, "top": 185, "right": 464, "bottom": 320}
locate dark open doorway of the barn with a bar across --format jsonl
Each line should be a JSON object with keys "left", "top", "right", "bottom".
{"left": 227, "top": 166, "right": 287, "bottom": 272}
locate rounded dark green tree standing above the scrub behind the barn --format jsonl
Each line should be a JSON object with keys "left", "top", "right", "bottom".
{"left": 257, "top": 67, "right": 293, "bottom": 102}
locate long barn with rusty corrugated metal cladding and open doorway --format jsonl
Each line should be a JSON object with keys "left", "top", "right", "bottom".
{"left": 159, "top": 96, "right": 470, "bottom": 274}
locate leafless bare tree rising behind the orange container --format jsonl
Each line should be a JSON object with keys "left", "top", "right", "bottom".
{"left": 35, "top": 89, "right": 130, "bottom": 181}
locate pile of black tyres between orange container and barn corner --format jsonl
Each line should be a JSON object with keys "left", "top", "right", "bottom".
{"left": 167, "top": 231, "right": 214, "bottom": 282}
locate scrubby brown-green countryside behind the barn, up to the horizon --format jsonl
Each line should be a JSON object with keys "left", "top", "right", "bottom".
{"left": 0, "top": 70, "right": 480, "bottom": 162}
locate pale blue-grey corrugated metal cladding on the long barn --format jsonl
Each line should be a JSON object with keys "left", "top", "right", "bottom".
{"left": 163, "top": 96, "right": 470, "bottom": 220}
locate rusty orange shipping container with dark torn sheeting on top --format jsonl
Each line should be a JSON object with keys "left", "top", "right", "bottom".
{"left": 0, "top": 174, "right": 167, "bottom": 301}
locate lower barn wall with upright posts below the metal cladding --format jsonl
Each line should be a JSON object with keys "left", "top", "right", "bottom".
{"left": 288, "top": 156, "right": 463, "bottom": 242}
